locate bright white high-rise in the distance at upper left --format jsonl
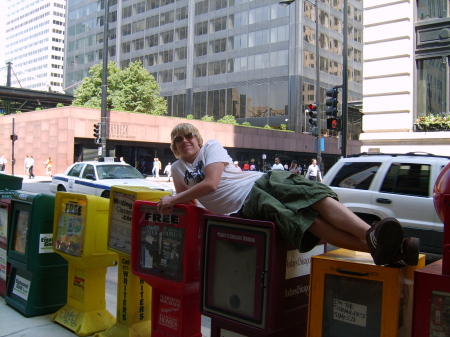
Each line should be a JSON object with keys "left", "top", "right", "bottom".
{"left": 3, "top": 0, "right": 66, "bottom": 92}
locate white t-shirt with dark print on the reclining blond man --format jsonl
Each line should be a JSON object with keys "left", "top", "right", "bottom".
{"left": 172, "top": 139, "right": 263, "bottom": 214}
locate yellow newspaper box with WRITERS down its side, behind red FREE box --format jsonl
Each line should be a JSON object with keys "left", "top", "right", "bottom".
{"left": 95, "top": 186, "right": 170, "bottom": 337}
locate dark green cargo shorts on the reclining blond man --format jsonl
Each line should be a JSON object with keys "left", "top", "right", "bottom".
{"left": 242, "top": 170, "right": 338, "bottom": 253}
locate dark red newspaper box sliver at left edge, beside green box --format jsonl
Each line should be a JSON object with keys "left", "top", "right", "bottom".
{"left": 0, "top": 199, "right": 11, "bottom": 297}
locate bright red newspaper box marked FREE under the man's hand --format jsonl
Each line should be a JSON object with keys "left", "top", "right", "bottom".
{"left": 131, "top": 200, "right": 206, "bottom": 337}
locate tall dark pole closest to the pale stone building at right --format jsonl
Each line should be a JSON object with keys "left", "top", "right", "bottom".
{"left": 341, "top": 0, "right": 348, "bottom": 158}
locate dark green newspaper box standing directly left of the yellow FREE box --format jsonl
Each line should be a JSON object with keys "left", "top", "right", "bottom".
{"left": 5, "top": 191, "right": 68, "bottom": 317}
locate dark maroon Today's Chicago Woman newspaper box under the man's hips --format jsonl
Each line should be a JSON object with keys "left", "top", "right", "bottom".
{"left": 200, "top": 215, "right": 325, "bottom": 337}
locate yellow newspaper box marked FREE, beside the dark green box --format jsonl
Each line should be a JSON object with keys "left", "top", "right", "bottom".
{"left": 52, "top": 192, "right": 118, "bottom": 336}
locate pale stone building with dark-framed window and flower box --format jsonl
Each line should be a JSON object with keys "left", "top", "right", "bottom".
{"left": 360, "top": 0, "right": 450, "bottom": 155}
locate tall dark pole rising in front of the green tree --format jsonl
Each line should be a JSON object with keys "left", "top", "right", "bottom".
{"left": 99, "top": 0, "right": 109, "bottom": 157}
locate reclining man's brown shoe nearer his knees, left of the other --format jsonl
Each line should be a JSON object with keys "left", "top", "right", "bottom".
{"left": 366, "top": 218, "right": 403, "bottom": 266}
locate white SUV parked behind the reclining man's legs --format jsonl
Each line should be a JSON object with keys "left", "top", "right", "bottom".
{"left": 323, "top": 153, "right": 450, "bottom": 254}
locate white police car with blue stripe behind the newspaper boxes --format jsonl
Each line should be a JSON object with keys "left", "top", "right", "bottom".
{"left": 50, "top": 161, "right": 173, "bottom": 198}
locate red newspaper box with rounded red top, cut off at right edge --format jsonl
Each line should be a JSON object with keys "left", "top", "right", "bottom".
{"left": 412, "top": 164, "right": 450, "bottom": 337}
